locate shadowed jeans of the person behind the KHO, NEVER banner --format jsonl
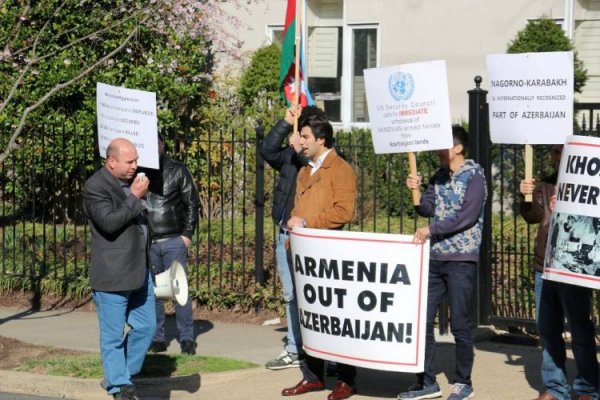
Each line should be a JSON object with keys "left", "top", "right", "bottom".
{"left": 538, "top": 280, "right": 599, "bottom": 400}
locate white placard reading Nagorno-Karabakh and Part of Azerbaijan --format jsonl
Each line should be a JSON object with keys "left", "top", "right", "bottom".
{"left": 487, "top": 51, "right": 574, "bottom": 144}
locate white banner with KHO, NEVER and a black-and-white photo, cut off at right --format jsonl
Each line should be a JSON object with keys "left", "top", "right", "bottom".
{"left": 544, "top": 136, "right": 600, "bottom": 289}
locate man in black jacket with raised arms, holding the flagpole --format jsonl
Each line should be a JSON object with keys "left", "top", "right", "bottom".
{"left": 260, "top": 107, "right": 308, "bottom": 370}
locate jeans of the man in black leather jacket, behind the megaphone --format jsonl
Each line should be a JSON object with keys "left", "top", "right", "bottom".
{"left": 150, "top": 236, "right": 196, "bottom": 343}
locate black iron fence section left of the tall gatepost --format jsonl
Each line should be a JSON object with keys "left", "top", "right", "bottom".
{"left": 0, "top": 117, "right": 433, "bottom": 308}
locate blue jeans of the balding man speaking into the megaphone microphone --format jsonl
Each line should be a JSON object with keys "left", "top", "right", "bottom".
{"left": 92, "top": 273, "right": 156, "bottom": 394}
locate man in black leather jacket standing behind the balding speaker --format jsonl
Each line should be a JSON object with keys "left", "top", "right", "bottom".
{"left": 145, "top": 136, "right": 199, "bottom": 354}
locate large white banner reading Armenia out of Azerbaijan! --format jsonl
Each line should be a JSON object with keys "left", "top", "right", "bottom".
{"left": 291, "top": 228, "right": 429, "bottom": 372}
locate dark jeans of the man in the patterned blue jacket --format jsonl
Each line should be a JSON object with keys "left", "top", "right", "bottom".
{"left": 417, "top": 260, "right": 477, "bottom": 386}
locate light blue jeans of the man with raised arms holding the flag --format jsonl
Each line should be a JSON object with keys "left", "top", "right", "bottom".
{"left": 275, "top": 231, "right": 302, "bottom": 354}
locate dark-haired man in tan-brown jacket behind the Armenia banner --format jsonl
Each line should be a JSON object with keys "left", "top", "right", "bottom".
{"left": 281, "top": 107, "right": 356, "bottom": 400}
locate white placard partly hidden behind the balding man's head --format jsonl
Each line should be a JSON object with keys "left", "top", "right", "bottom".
{"left": 96, "top": 82, "right": 159, "bottom": 169}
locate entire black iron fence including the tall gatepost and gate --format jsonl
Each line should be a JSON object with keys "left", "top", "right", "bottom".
{"left": 0, "top": 79, "right": 600, "bottom": 327}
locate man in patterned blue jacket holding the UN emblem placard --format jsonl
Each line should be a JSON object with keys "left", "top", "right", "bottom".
{"left": 398, "top": 125, "right": 487, "bottom": 400}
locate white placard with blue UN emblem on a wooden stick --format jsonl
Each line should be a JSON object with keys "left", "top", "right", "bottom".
{"left": 364, "top": 60, "right": 452, "bottom": 154}
